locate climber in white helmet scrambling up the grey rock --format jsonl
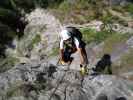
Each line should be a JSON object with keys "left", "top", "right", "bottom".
{"left": 60, "top": 27, "right": 88, "bottom": 70}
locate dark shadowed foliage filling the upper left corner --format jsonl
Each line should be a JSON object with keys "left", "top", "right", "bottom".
{"left": 0, "top": 0, "right": 64, "bottom": 57}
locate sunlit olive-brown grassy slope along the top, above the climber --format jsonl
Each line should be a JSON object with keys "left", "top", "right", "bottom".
{"left": 51, "top": 0, "right": 133, "bottom": 24}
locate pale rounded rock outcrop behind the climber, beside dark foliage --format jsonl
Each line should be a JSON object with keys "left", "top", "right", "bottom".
{"left": 13, "top": 8, "right": 61, "bottom": 59}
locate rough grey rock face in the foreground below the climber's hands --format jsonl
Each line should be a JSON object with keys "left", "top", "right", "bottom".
{"left": 0, "top": 57, "right": 133, "bottom": 100}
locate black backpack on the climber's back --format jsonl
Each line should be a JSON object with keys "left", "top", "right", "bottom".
{"left": 66, "top": 27, "right": 82, "bottom": 41}
